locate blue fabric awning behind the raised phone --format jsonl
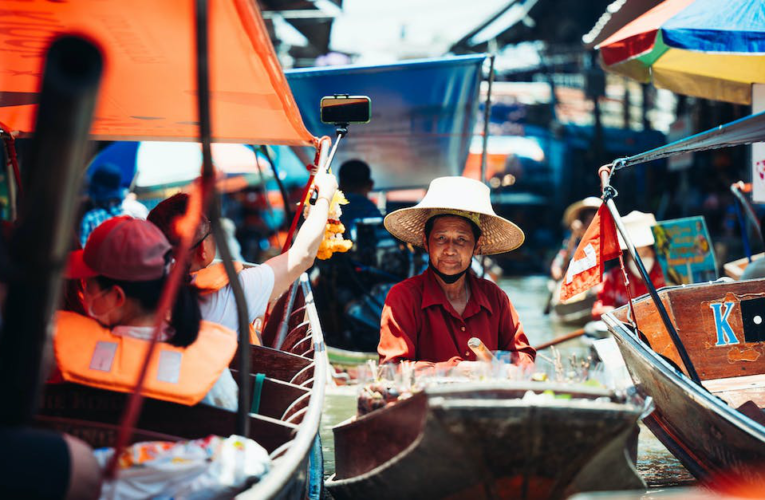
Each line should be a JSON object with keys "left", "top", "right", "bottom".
{"left": 286, "top": 55, "right": 485, "bottom": 190}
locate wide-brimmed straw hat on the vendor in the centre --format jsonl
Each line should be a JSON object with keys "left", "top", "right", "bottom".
{"left": 385, "top": 177, "right": 525, "bottom": 255}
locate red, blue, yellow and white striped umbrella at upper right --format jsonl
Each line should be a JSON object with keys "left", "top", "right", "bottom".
{"left": 597, "top": 0, "right": 765, "bottom": 104}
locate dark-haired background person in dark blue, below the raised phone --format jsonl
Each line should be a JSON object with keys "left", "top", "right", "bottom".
{"left": 338, "top": 160, "right": 382, "bottom": 230}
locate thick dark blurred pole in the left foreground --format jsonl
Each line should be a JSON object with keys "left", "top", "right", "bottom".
{"left": 0, "top": 36, "right": 103, "bottom": 425}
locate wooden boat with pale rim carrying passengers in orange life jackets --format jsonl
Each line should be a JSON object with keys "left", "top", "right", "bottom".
{"left": 36, "top": 276, "right": 327, "bottom": 498}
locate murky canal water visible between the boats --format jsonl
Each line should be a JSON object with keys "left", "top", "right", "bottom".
{"left": 321, "top": 276, "right": 695, "bottom": 490}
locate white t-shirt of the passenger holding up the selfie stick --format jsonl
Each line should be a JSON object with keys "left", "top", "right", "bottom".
{"left": 199, "top": 265, "right": 275, "bottom": 335}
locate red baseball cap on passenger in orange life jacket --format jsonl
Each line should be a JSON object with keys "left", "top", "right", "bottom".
{"left": 66, "top": 215, "right": 172, "bottom": 281}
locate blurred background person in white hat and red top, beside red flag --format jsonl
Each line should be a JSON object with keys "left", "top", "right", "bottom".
{"left": 592, "top": 210, "right": 666, "bottom": 319}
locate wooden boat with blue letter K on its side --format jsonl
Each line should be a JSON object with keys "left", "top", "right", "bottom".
{"left": 604, "top": 280, "right": 765, "bottom": 484}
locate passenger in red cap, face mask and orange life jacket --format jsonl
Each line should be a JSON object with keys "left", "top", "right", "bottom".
{"left": 53, "top": 216, "right": 237, "bottom": 410}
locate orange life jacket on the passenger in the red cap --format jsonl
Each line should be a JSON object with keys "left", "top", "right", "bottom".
{"left": 53, "top": 311, "right": 237, "bottom": 405}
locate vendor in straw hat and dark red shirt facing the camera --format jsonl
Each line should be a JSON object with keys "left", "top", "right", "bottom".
{"left": 377, "top": 177, "right": 536, "bottom": 368}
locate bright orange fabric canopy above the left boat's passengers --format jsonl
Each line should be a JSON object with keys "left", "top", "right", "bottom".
{"left": 0, "top": 0, "right": 318, "bottom": 146}
